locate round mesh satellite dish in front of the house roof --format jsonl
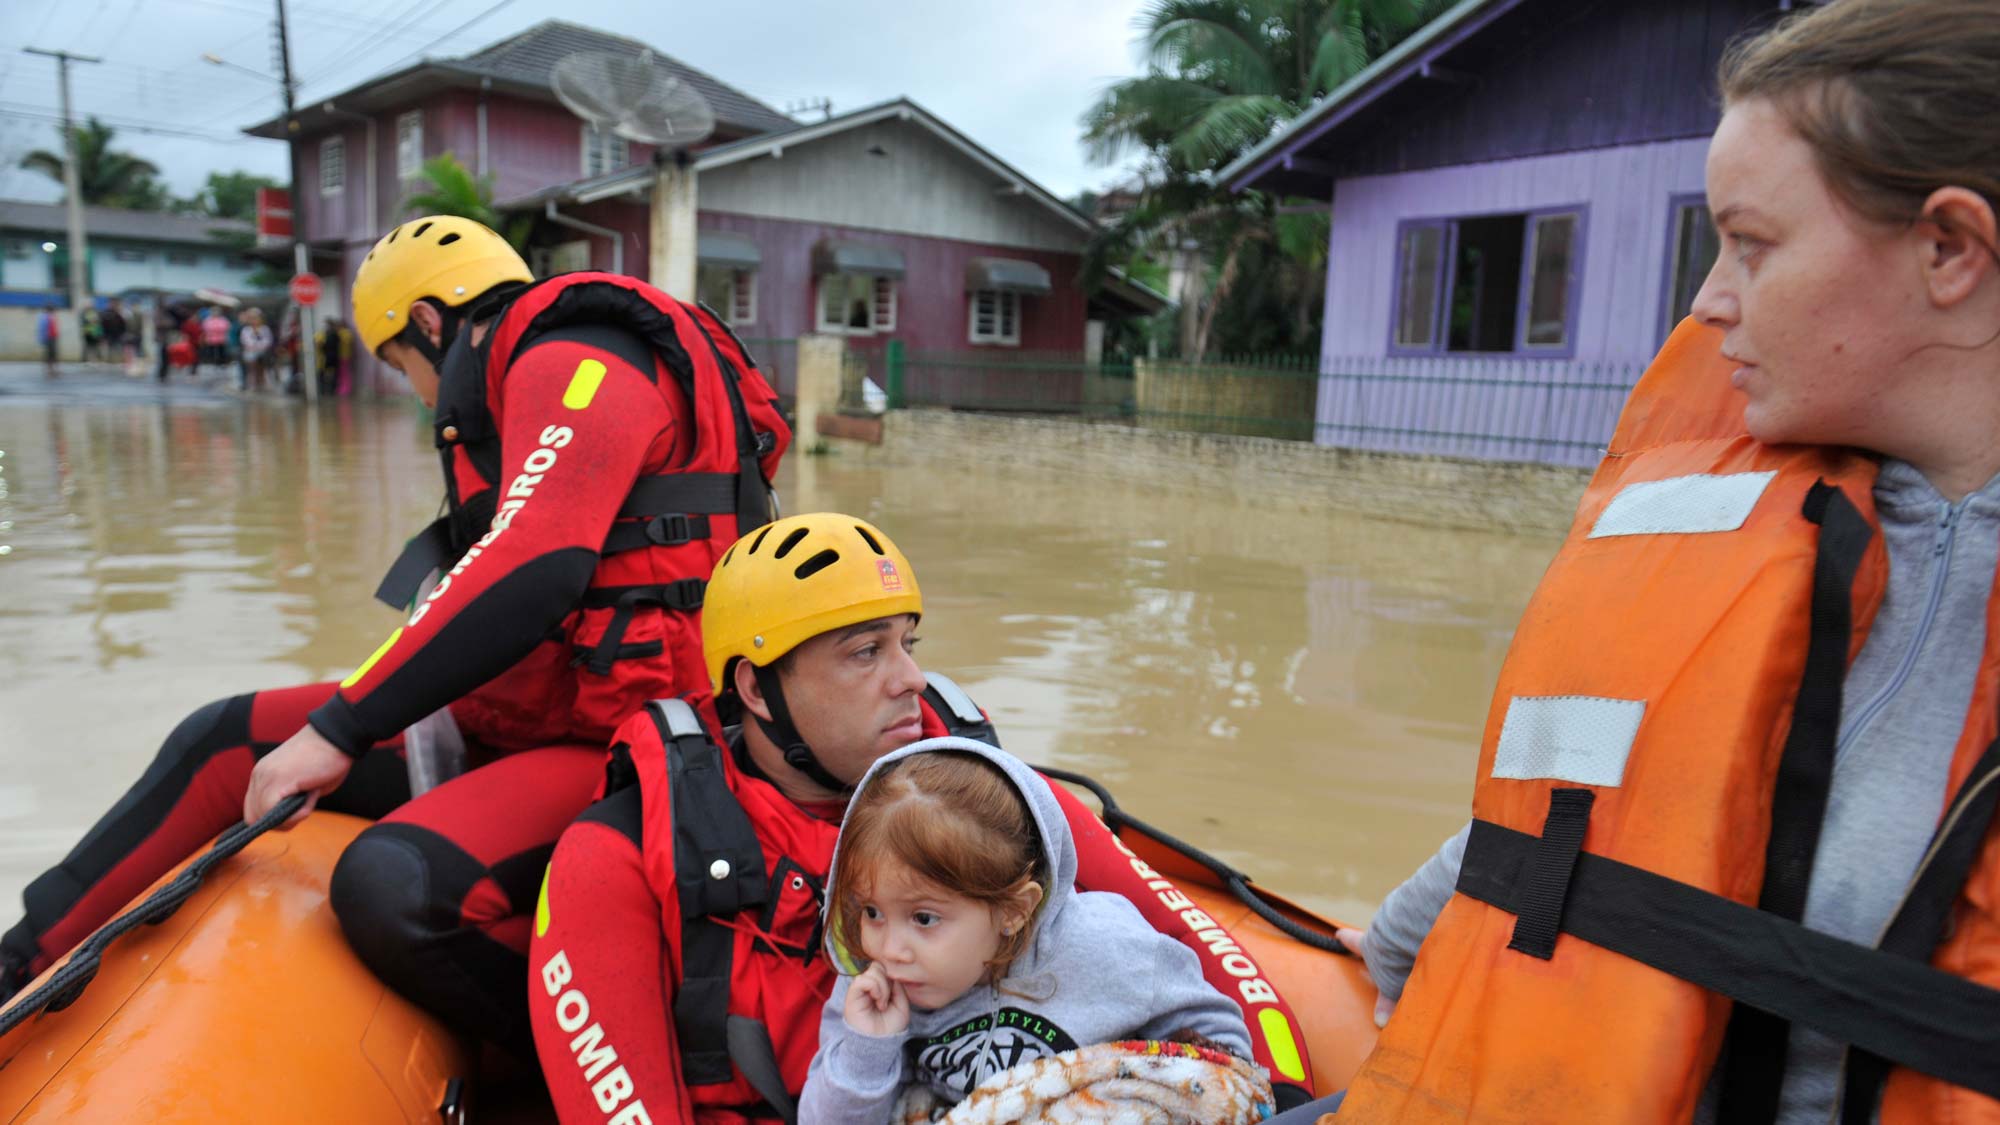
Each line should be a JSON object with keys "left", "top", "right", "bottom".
{"left": 550, "top": 50, "right": 716, "bottom": 154}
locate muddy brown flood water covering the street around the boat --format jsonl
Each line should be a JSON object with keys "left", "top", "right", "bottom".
{"left": 0, "top": 378, "right": 1556, "bottom": 927}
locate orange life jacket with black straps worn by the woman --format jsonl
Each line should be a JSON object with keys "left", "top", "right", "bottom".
{"left": 1340, "top": 320, "right": 2000, "bottom": 1125}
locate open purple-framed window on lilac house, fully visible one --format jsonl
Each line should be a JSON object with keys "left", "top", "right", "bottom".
{"left": 1388, "top": 204, "right": 1586, "bottom": 356}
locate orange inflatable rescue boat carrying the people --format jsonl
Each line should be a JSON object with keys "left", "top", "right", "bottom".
{"left": 0, "top": 775, "right": 1376, "bottom": 1125}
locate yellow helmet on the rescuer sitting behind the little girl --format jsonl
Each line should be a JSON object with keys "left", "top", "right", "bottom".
{"left": 702, "top": 512, "right": 924, "bottom": 697}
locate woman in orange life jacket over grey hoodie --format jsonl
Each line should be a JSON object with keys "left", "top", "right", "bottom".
{"left": 1272, "top": 0, "right": 2000, "bottom": 1125}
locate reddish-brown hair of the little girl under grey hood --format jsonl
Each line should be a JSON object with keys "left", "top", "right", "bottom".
{"left": 828, "top": 751, "right": 1048, "bottom": 977}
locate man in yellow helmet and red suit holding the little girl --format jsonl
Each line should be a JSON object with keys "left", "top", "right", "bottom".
{"left": 528, "top": 512, "right": 1310, "bottom": 1125}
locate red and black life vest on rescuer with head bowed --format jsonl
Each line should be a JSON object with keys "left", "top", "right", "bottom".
{"left": 376, "top": 272, "right": 792, "bottom": 749}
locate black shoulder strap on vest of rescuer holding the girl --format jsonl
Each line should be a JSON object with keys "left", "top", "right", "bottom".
{"left": 646, "top": 699, "right": 770, "bottom": 1085}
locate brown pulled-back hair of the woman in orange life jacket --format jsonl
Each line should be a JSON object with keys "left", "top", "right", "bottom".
{"left": 1718, "top": 0, "right": 2000, "bottom": 226}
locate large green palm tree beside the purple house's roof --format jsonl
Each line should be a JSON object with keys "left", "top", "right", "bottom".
{"left": 1082, "top": 0, "right": 1444, "bottom": 354}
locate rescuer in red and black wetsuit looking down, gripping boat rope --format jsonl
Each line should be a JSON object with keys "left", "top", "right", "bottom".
{"left": 0, "top": 218, "right": 790, "bottom": 1049}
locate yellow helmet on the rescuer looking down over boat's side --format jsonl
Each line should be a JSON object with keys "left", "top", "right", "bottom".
{"left": 352, "top": 214, "right": 534, "bottom": 352}
